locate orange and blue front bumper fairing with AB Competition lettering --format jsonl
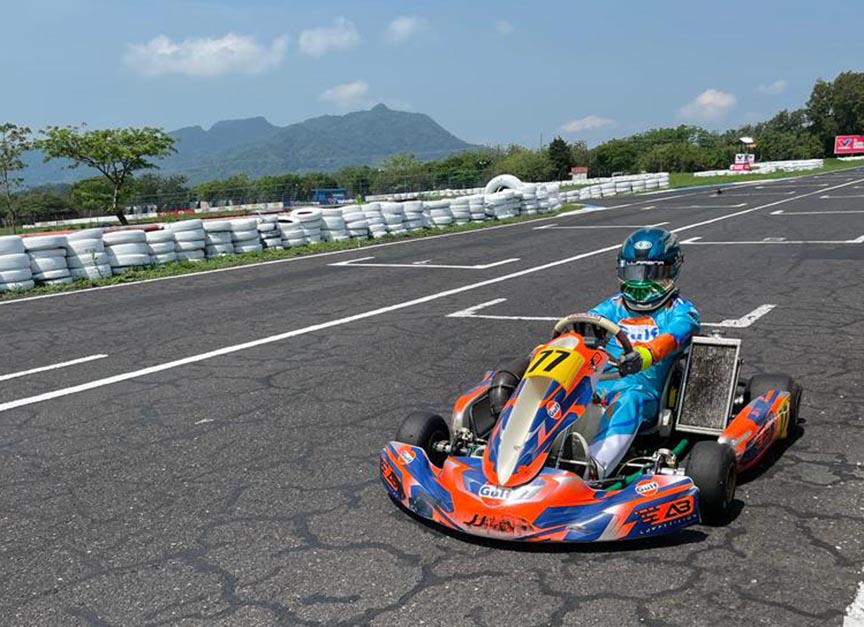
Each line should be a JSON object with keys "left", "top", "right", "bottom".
{"left": 381, "top": 442, "right": 699, "bottom": 542}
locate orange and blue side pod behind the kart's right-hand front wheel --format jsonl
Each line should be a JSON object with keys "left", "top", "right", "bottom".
{"left": 719, "top": 390, "right": 790, "bottom": 472}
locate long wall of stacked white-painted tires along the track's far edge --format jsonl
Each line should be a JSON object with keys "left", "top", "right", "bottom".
{"left": 0, "top": 173, "right": 628, "bottom": 291}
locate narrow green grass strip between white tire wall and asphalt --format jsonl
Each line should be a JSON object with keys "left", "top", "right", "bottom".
{"left": 0, "top": 204, "right": 580, "bottom": 301}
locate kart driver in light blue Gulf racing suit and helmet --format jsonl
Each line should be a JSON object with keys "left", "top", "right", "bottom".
{"left": 489, "top": 227, "right": 699, "bottom": 479}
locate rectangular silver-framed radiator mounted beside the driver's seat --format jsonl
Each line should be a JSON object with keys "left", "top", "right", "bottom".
{"left": 675, "top": 336, "right": 741, "bottom": 435}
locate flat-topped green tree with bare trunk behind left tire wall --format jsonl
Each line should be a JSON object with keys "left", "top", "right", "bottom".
{"left": 38, "top": 126, "right": 174, "bottom": 224}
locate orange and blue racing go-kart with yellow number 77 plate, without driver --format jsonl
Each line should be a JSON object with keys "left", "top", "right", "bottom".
{"left": 380, "top": 314, "right": 801, "bottom": 542}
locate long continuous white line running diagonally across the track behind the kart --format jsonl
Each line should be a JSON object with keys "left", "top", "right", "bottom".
{"left": 0, "top": 174, "right": 864, "bottom": 412}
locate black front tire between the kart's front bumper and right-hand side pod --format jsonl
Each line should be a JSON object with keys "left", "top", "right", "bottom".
{"left": 685, "top": 441, "right": 737, "bottom": 525}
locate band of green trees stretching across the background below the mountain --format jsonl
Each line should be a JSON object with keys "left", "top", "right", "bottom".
{"left": 0, "top": 72, "right": 864, "bottom": 231}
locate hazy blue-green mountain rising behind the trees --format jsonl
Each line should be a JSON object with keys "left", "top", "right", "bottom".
{"left": 24, "top": 104, "right": 475, "bottom": 185}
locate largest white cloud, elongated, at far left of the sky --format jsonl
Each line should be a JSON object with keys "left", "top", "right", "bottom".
{"left": 125, "top": 33, "right": 288, "bottom": 78}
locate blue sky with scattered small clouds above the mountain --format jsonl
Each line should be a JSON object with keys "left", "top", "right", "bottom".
{"left": 0, "top": 0, "right": 864, "bottom": 145}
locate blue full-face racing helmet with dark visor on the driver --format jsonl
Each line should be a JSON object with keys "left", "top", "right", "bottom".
{"left": 618, "top": 227, "right": 684, "bottom": 311}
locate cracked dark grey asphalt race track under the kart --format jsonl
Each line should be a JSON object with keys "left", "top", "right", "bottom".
{"left": 0, "top": 170, "right": 864, "bottom": 626}
